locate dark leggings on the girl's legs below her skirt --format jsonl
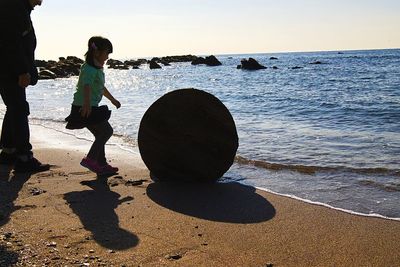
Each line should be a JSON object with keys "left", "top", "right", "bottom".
{"left": 87, "top": 121, "right": 113, "bottom": 165}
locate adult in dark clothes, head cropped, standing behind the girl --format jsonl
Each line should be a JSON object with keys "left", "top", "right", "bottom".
{"left": 0, "top": 0, "right": 50, "bottom": 173}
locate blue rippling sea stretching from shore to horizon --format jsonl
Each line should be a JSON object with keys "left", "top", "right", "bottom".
{"left": 0, "top": 49, "right": 400, "bottom": 221}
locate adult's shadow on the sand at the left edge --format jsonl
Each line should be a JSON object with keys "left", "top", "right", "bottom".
{"left": 0, "top": 168, "right": 32, "bottom": 227}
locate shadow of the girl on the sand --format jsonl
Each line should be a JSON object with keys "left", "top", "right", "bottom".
{"left": 64, "top": 177, "right": 139, "bottom": 250}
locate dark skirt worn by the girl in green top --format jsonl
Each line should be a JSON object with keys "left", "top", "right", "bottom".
{"left": 65, "top": 105, "right": 111, "bottom": 130}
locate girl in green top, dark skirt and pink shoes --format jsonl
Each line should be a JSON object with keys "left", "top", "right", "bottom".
{"left": 65, "top": 36, "right": 121, "bottom": 175}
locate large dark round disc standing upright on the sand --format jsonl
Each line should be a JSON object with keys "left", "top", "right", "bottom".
{"left": 138, "top": 89, "right": 239, "bottom": 182}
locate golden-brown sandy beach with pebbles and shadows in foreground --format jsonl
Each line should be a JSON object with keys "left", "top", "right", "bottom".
{"left": 0, "top": 125, "right": 400, "bottom": 266}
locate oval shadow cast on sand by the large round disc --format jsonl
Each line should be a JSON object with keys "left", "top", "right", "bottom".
{"left": 147, "top": 182, "right": 275, "bottom": 224}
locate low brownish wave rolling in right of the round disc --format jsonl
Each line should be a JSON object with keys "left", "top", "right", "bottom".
{"left": 235, "top": 155, "right": 400, "bottom": 178}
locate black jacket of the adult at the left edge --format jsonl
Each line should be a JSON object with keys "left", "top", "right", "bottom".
{"left": 0, "top": 0, "right": 38, "bottom": 85}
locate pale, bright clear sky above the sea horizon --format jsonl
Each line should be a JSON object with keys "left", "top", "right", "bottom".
{"left": 32, "top": 0, "right": 400, "bottom": 59}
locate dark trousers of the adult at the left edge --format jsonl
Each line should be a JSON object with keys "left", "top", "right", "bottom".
{"left": 0, "top": 81, "right": 32, "bottom": 155}
